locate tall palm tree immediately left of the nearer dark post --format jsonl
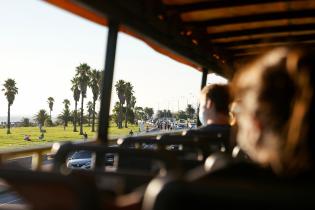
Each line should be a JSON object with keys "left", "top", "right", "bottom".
{"left": 89, "top": 69, "right": 102, "bottom": 132}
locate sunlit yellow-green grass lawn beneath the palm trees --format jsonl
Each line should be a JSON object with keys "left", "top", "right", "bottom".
{"left": 0, "top": 124, "right": 139, "bottom": 151}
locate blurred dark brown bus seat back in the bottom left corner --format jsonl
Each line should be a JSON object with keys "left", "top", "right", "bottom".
{"left": 0, "top": 167, "right": 100, "bottom": 210}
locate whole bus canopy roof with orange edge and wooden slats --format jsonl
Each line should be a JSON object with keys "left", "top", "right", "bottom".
{"left": 46, "top": 0, "right": 315, "bottom": 77}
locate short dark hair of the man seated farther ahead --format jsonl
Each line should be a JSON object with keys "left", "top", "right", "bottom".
{"left": 201, "top": 84, "right": 231, "bottom": 114}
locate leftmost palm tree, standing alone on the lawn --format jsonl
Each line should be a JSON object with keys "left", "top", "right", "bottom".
{"left": 2, "top": 79, "right": 18, "bottom": 134}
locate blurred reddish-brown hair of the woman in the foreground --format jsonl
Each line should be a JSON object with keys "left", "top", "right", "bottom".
{"left": 232, "top": 48, "right": 315, "bottom": 176}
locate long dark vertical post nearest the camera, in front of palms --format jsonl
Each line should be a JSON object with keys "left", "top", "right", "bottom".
{"left": 98, "top": 20, "right": 119, "bottom": 144}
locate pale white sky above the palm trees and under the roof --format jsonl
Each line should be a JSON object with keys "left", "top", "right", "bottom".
{"left": 0, "top": 0, "right": 225, "bottom": 118}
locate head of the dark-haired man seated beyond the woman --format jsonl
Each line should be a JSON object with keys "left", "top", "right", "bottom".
{"left": 199, "top": 84, "right": 231, "bottom": 125}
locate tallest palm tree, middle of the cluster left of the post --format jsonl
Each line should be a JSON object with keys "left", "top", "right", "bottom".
{"left": 75, "top": 63, "right": 91, "bottom": 135}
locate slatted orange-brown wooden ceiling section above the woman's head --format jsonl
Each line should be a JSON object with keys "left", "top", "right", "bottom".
{"left": 162, "top": 0, "right": 315, "bottom": 63}
